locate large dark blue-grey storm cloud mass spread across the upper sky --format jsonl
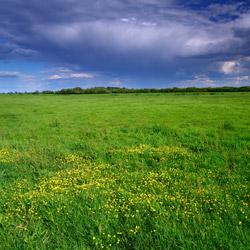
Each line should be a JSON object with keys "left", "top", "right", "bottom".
{"left": 0, "top": 0, "right": 250, "bottom": 86}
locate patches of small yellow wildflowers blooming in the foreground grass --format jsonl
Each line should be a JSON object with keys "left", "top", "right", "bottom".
{"left": 0, "top": 145, "right": 250, "bottom": 248}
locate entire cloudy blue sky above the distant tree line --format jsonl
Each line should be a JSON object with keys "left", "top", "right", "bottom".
{"left": 0, "top": 0, "right": 250, "bottom": 93}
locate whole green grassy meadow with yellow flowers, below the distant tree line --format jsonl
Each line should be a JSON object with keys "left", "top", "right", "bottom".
{"left": 0, "top": 93, "right": 250, "bottom": 250}
